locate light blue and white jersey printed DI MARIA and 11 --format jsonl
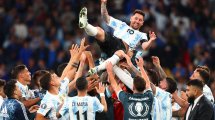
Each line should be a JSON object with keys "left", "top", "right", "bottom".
{"left": 59, "top": 96, "right": 104, "bottom": 120}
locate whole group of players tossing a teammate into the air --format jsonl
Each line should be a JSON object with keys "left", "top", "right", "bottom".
{"left": 0, "top": 0, "right": 214, "bottom": 120}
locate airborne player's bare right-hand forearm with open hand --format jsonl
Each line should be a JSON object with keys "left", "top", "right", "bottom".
{"left": 142, "top": 31, "right": 157, "bottom": 50}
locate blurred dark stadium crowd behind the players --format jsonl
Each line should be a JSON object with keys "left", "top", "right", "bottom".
{"left": 0, "top": 0, "right": 215, "bottom": 97}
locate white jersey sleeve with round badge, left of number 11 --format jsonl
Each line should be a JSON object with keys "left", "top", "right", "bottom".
{"left": 37, "top": 101, "right": 53, "bottom": 116}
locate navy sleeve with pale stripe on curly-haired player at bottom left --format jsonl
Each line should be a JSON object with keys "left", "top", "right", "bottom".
{"left": 15, "top": 102, "right": 29, "bottom": 120}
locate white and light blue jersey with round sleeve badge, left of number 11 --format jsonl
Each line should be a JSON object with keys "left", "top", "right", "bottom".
{"left": 37, "top": 78, "right": 69, "bottom": 120}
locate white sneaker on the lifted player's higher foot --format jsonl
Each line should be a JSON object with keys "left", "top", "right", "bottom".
{"left": 79, "top": 7, "right": 88, "bottom": 28}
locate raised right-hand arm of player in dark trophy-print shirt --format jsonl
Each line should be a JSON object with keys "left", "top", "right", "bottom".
{"left": 135, "top": 57, "right": 151, "bottom": 89}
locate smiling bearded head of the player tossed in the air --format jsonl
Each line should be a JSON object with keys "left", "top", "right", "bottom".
{"left": 130, "top": 10, "right": 145, "bottom": 30}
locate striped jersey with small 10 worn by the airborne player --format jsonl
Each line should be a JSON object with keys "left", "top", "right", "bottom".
{"left": 108, "top": 17, "right": 148, "bottom": 49}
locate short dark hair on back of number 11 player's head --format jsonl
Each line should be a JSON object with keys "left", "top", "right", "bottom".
{"left": 76, "top": 77, "right": 88, "bottom": 91}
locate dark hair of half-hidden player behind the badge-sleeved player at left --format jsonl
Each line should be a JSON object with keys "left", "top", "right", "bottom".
{"left": 29, "top": 70, "right": 48, "bottom": 89}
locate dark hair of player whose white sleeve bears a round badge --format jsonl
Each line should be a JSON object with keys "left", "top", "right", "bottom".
{"left": 40, "top": 72, "right": 52, "bottom": 90}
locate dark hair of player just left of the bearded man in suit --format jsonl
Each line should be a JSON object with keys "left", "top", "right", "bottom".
{"left": 166, "top": 77, "right": 177, "bottom": 94}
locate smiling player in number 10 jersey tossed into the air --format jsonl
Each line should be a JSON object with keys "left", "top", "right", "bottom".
{"left": 79, "top": 0, "right": 156, "bottom": 74}
